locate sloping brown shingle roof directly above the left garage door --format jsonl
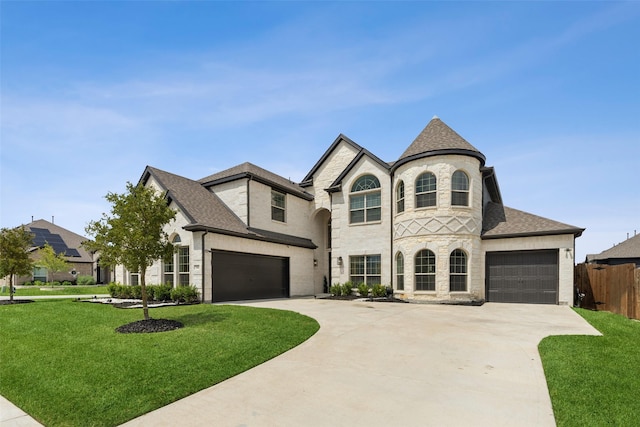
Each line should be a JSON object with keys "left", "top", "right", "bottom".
{"left": 141, "top": 166, "right": 316, "bottom": 248}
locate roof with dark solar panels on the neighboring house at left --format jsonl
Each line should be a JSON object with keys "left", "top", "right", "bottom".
{"left": 24, "top": 219, "right": 93, "bottom": 262}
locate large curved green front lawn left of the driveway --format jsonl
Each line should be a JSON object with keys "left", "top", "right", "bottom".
{"left": 0, "top": 299, "right": 319, "bottom": 426}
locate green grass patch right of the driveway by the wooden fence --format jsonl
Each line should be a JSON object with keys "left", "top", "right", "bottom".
{"left": 539, "top": 309, "right": 640, "bottom": 427}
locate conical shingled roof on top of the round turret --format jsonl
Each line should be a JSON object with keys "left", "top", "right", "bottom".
{"left": 393, "top": 117, "right": 486, "bottom": 169}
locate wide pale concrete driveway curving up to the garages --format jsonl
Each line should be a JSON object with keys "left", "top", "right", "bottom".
{"left": 125, "top": 299, "right": 599, "bottom": 427}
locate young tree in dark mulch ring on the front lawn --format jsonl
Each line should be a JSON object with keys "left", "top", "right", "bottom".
{"left": 84, "top": 182, "right": 176, "bottom": 320}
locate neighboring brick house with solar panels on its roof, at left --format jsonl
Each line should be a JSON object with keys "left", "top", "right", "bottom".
{"left": 10, "top": 219, "right": 94, "bottom": 285}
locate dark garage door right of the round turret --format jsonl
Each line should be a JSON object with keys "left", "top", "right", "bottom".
{"left": 486, "top": 250, "right": 558, "bottom": 304}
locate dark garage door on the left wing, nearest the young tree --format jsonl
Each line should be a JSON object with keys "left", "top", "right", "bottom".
{"left": 211, "top": 251, "right": 289, "bottom": 302}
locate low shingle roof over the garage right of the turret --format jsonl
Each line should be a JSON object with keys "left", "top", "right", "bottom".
{"left": 482, "top": 202, "right": 584, "bottom": 239}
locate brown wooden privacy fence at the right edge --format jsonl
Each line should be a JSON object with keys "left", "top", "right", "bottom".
{"left": 574, "top": 264, "right": 640, "bottom": 319}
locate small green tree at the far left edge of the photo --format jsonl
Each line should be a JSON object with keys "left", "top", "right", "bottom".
{"left": 0, "top": 227, "right": 33, "bottom": 302}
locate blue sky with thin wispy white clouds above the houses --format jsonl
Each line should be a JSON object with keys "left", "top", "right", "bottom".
{"left": 0, "top": 1, "right": 640, "bottom": 261}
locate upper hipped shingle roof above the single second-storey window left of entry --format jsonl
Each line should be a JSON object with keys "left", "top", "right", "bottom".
{"left": 198, "top": 162, "right": 313, "bottom": 200}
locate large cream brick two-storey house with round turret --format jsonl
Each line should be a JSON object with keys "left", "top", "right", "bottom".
{"left": 115, "top": 118, "right": 584, "bottom": 304}
